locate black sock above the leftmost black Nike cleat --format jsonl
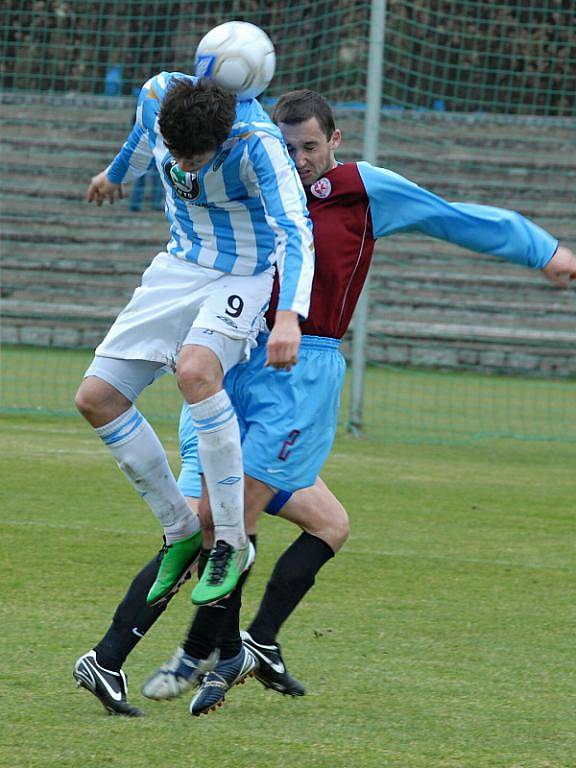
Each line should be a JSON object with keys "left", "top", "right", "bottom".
{"left": 94, "top": 555, "right": 166, "bottom": 671}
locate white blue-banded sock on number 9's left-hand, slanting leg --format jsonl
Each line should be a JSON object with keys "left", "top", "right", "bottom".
{"left": 96, "top": 406, "right": 200, "bottom": 543}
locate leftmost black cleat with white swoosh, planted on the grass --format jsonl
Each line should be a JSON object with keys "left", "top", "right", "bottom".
{"left": 72, "top": 650, "right": 144, "bottom": 717}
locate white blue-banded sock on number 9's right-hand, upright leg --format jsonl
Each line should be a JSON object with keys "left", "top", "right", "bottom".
{"left": 190, "top": 389, "right": 246, "bottom": 547}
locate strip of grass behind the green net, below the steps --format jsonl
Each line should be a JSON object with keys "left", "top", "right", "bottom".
{"left": 0, "top": 345, "right": 576, "bottom": 444}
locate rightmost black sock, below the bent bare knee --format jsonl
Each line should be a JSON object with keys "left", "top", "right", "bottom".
{"left": 248, "top": 532, "right": 334, "bottom": 645}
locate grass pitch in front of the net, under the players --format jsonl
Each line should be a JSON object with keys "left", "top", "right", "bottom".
{"left": 0, "top": 415, "right": 576, "bottom": 768}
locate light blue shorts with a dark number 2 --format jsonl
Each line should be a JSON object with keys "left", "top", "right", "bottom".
{"left": 178, "top": 336, "right": 346, "bottom": 496}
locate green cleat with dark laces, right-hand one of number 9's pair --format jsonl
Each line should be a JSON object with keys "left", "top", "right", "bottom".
{"left": 192, "top": 541, "right": 256, "bottom": 605}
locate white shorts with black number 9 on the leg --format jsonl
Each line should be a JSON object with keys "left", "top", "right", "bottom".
{"left": 95, "top": 252, "right": 273, "bottom": 370}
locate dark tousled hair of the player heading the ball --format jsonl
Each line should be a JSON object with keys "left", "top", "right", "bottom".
{"left": 158, "top": 77, "right": 236, "bottom": 158}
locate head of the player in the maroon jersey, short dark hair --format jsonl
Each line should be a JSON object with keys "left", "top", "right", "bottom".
{"left": 272, "top": 90, "right": 341, "bottom": 187}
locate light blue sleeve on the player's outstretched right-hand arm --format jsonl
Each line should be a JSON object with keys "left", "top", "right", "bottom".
{"left": 358, "top": 162, "right": 558, "bottom": 269}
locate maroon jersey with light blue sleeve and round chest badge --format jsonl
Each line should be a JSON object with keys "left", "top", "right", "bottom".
{"left": 272, "top": 162, "right": 558, "bottom": 339}
